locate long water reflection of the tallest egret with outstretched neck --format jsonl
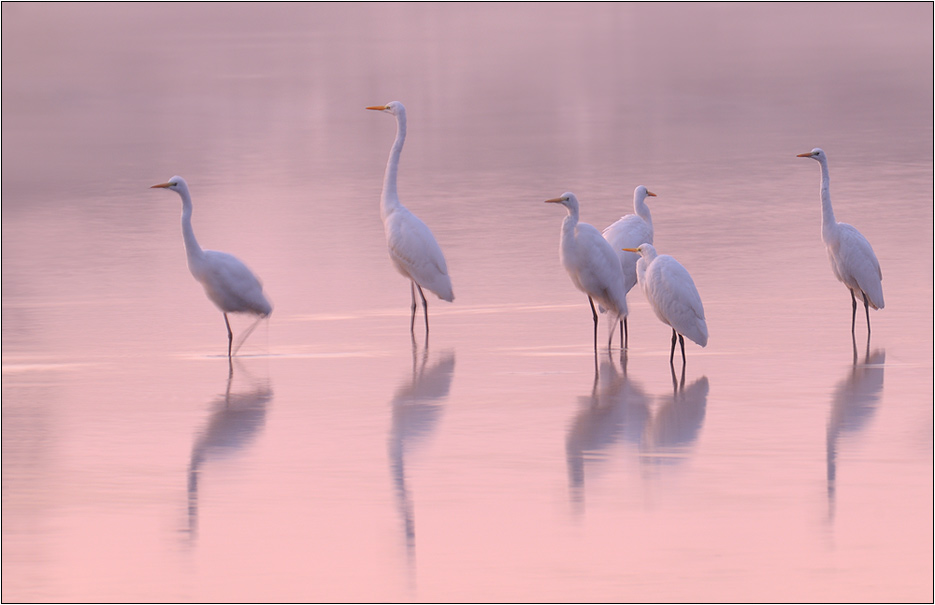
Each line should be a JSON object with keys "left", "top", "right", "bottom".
{"left": 388, "top": 337, "right": 455, "bottom": 573}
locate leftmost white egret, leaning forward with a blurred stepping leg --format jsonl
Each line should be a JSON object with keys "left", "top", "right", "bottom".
{"left": 150, "top": 176, "right": 273, "bottom": 359}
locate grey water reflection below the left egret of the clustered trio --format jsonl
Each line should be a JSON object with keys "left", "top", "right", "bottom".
{"left": 565, "top": 350, "right": 650, "bottom": 512}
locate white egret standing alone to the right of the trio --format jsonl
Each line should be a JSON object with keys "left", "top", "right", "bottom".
{"left": 796, "top": 147, "right": 883, "bottom": 338}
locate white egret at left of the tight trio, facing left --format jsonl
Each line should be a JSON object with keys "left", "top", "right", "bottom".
{"left": 546, "top": 192, "right": 627, "bottom": 351}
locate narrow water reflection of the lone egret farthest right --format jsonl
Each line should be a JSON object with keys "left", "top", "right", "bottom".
{"left": 826, "top": 335, "right": 886, "bottom": 521}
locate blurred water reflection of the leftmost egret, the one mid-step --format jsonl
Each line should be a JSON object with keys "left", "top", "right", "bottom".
{"left": 188, "top": 362, "right": 273, "bottom": 539}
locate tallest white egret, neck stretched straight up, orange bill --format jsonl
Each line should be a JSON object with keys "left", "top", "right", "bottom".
{"left": 367, "top": 101, "right": 455, "bottom": 334}
